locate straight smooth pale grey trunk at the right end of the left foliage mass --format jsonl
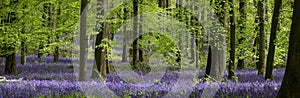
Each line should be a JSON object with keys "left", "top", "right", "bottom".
{"left": 79, "top": 0, "right": 88, "bottom": 81}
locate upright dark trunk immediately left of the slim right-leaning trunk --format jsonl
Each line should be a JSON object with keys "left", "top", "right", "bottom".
{"left": 257, "top": 0, "right": 265, "bottom": 75}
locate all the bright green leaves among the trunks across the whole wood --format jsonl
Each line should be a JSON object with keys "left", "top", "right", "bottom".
{"left": 0, "top": 0, "right": 293, "bottom": 72}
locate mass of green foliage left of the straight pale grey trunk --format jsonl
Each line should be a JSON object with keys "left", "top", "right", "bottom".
{"left": 0, "top": 0, "right": 80, "bottom": 55}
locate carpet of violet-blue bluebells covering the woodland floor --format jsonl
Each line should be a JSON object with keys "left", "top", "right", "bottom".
{"left": 0, "top": 56, "right": 284, "bottom": 98}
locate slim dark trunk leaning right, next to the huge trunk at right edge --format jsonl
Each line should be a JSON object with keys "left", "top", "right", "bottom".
{"left": 265, "top": 0, "right": 282, "bottom": 80}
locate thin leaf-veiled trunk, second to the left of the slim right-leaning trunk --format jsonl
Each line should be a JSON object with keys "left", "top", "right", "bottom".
{"left": 237, "top": 0, "right": 246, "bottom": 69}
